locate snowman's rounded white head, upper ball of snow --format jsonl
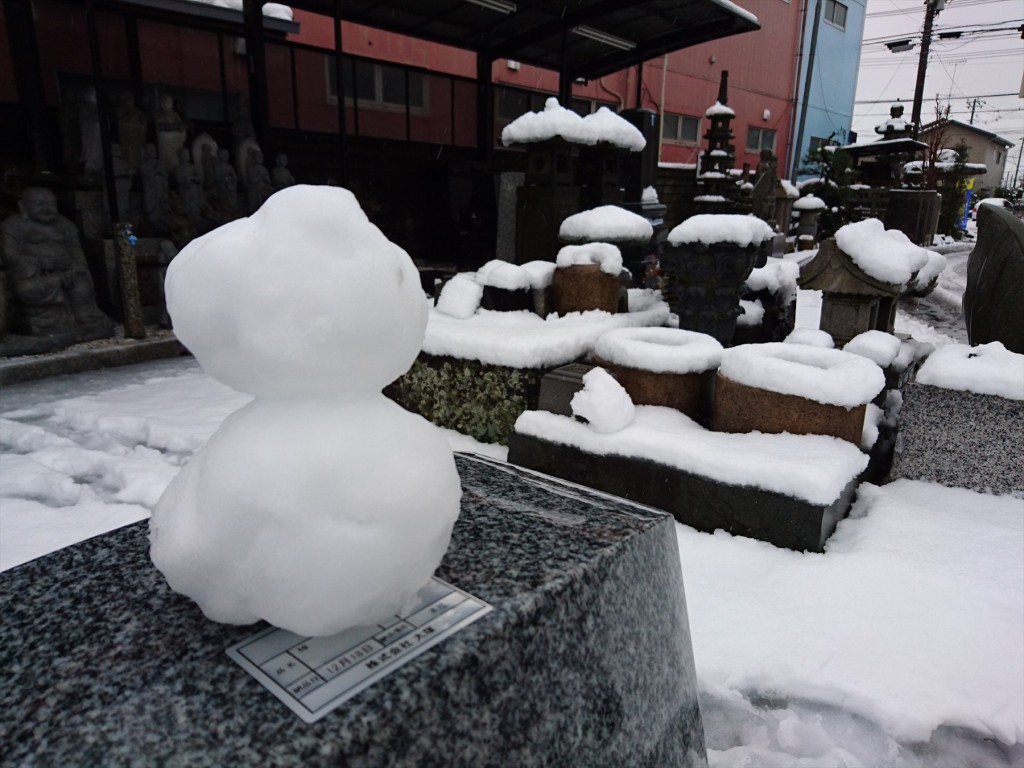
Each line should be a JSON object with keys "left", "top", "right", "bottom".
{"left": 166, "top": 185, "right": 427, "bottom": 397}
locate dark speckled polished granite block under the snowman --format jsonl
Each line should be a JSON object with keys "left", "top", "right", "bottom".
{"left": 0, "top": 456, "right": 707, "bottom": 767}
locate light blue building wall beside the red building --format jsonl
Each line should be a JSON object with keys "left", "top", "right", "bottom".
{"left": 788, "top": 0, "right": 866, "bottom": 176}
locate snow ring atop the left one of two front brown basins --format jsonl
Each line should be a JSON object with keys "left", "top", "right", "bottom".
{"left": 594, "top": 328, "right": 722, "bottom": 374}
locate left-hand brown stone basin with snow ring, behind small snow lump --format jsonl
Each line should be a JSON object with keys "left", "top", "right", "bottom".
{"left": 593, "top": 328, "right": 722, "bottom": 426}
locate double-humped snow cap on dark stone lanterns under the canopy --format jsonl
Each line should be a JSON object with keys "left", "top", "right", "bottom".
{"left": 502, "top": 97, "right": 647, "bottom": 152}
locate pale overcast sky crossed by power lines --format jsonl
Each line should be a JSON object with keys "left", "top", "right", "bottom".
{"left": 853, "top": 0, "right": 1024, "bottom": 183}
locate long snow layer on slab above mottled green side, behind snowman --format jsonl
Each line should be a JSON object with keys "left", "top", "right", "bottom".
{"left": 423, "top": 301, "right": 669, "bottom": 368}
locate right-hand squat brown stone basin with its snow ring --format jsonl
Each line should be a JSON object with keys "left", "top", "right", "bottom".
{"left": 712, "top": 343, "right": 886, "bottom": 446}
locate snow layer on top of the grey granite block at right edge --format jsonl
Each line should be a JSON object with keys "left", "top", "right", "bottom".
{"left": 915, "top": 341, "right": 1024, "bottom": 400}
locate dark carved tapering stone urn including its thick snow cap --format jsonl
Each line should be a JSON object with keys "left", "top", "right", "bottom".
{"left": 659, "top": 214, "right": 773, "bottom": 346}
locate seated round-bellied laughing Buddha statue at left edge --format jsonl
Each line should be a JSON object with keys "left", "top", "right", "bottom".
{"left": 0, "top": 186, "right": 114, "bottom": 344}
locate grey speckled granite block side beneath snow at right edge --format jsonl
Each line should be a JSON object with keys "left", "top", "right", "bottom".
{"left": 890, "top": 382, "right": 1024, "bottom": 494}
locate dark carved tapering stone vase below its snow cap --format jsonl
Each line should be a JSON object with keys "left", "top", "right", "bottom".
{"left": 659, "top": 243, "right": 767, "bottom": 346}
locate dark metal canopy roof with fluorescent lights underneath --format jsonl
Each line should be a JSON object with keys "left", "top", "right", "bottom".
{"left": 280, "top": 0, "right": 760, "bottom": 79}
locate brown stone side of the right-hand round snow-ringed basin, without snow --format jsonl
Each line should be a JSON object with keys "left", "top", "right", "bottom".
{"left": 712, "top": 373, "right": 867, "bottom": 446}
